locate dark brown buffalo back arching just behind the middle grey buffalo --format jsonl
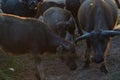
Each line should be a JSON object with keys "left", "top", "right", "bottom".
{"left": 35, "top": 1, "right": 64, "bottom": 18}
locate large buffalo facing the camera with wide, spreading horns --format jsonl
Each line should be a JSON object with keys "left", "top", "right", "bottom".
{"left": 76, "top": 0, "right": 120, "bottom": 73}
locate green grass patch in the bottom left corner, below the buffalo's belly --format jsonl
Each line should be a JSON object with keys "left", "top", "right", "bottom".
{"left": 0, "top": 52, "right": 33, "bottom": 80}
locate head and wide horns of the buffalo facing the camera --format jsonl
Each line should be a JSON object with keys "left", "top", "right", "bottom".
{"left": 75, "top": 30, "right": 120, "bottom": 63}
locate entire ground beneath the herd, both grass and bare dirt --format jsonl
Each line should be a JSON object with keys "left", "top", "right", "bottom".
{"left": 0, "top": 0, "right": 120, "bottom": 80}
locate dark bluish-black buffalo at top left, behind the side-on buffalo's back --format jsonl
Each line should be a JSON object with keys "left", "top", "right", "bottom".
{"left": 1, "top": 0, "right": 41, "bottom": 17}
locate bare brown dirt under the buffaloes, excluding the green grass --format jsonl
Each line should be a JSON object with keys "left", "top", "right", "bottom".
{"left": 12, "top": 34, "right": 120, "bottom": 80}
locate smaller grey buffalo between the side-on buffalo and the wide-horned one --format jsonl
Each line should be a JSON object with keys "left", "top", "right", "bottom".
{"left": 43, "top": 7, "right": 75, "bottom": 42}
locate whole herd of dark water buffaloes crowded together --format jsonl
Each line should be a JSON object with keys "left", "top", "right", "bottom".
{"left": 0, "top": 0, "right": 120, "bottom": 80}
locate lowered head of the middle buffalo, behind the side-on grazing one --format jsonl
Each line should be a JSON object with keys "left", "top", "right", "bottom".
{"left": 57, "top": 17, "right": 75, "bottom": 43}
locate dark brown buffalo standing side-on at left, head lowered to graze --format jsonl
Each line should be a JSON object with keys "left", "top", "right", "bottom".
{"left": 0, "top": 13, "right": 77, "bottom": 80}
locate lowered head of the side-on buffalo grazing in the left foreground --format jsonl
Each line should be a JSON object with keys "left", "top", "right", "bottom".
{"left": 57, "top": 44, "right": 77, "bottom": 70}
